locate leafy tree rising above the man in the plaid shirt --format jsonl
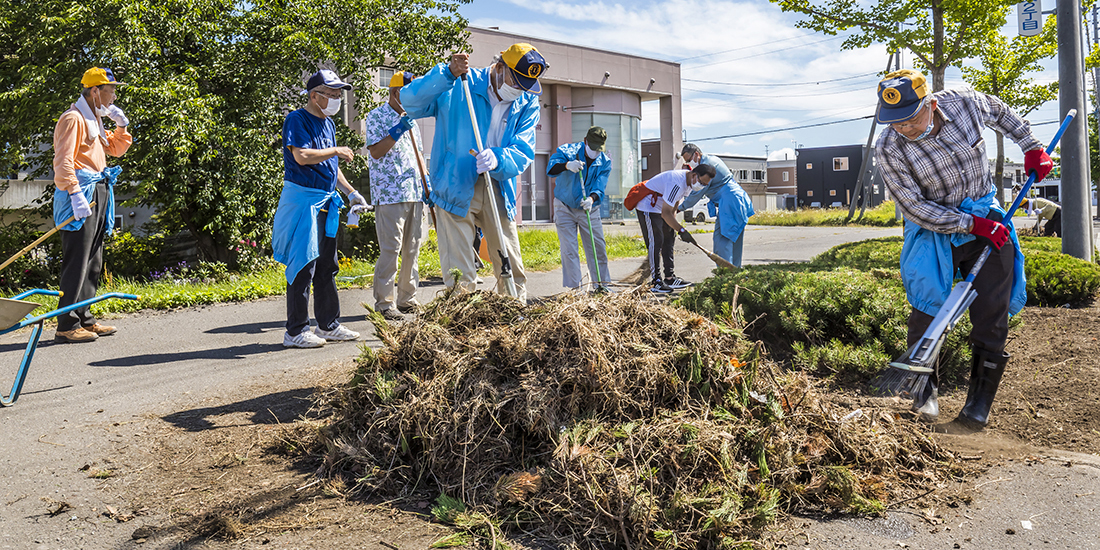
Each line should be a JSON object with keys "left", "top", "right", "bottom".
{"left": 770, "top": 0, "right": 1013, "bottom": 91}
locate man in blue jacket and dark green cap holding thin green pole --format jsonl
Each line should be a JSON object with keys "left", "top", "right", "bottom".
{"left": 547, "top": 127, "right": 612, "bottom": 292}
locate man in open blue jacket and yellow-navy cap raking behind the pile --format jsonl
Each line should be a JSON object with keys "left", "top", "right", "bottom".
{"left": 400, "top": 43, "right": 547, "bottom": 301}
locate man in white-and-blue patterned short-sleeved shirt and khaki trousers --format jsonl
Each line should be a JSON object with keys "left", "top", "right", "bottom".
{"left": 364, "top": 73, "right": 425, "bottom": 321}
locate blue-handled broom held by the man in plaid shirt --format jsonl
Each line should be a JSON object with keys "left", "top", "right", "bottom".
{"left": 871, "top": 109, "right": 1077, "bottom": 397}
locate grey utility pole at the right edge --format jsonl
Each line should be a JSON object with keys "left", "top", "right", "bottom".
{"left": 1057, "top": 1, "right": 1092, "bottom": 261}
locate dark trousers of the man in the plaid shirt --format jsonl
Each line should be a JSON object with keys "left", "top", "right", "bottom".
{"left": 908, "top": 239, "right": 1016, "bottom": 354}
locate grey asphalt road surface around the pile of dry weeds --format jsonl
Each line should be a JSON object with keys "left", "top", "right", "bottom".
{"left": 0, "top": 226, "right": 1100, "bottom": 549}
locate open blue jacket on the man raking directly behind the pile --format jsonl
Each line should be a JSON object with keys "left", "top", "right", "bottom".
{"left": 402, "top": 63, "right": 539, "bottom": 220}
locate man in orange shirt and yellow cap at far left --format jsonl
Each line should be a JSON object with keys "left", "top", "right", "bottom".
{"left": 54, "top": 67, "right": 133, "bottom": 342}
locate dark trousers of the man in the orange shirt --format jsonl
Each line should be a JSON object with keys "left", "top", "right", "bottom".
{"left": 57, "top": 183, "right": 108, "bottom": 332}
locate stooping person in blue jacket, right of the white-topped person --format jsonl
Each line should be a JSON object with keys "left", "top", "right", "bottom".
{"left": 680, "top": 143, "right": 756, "bottom": 267}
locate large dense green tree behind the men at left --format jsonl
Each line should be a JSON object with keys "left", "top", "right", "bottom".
{"left": 0, "top": 0, "right": 465, "bottom": 263}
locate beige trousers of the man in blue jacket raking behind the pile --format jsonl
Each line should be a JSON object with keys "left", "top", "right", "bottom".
{"left": 436, "top": 177, "right": 527, "bottom": 304}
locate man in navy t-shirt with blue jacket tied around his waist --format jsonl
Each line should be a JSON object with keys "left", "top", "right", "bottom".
{"left": 272, "top": 70, "right": 367, "bottom": 348}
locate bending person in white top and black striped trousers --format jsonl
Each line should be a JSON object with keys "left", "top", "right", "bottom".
{"left": 630, "top": 164, "right": 715, "bottom": 294}
